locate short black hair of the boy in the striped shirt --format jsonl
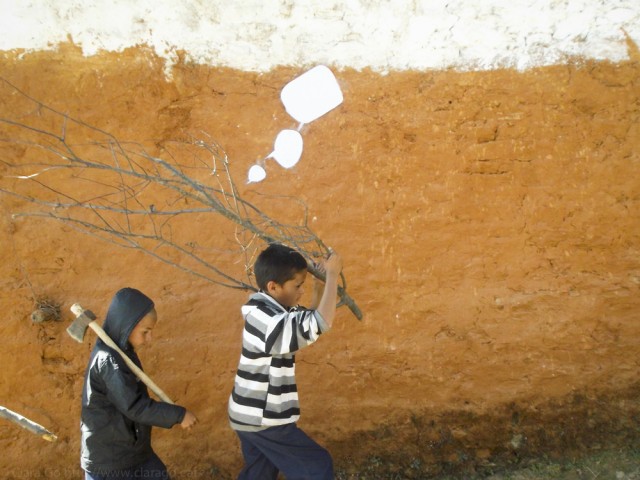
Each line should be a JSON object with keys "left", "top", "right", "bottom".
{"left": 253, "top": 243, "right": 307, "bottom": 292}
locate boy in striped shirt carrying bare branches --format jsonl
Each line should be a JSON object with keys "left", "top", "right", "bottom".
{"left": 229, "top": 244, "right": 342, "bottom": 480}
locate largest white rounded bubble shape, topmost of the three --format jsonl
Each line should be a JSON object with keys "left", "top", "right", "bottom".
{"left": 280, "top": 65, "right": 343, "bottom": 123}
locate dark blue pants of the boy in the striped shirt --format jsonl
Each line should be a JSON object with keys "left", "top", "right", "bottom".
{"left": 236, "top": 423, "right": 333, "bottom": 480}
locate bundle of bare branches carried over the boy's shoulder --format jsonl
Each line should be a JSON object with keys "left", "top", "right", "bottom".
{"left": 0, "top": 78, "right": 362, "bottom": 319}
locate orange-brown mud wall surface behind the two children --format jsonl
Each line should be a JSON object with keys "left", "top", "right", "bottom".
{"left": 0, "top": 45, "right": 640, "bottom": 480}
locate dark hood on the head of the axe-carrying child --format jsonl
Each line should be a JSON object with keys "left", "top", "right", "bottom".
{"left": 102, "top": 287, "right": 154, "bottom": 350}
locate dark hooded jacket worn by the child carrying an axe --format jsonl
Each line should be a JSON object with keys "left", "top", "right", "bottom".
{"left": 80, "top": 288, "right": 186, "bottom": 473}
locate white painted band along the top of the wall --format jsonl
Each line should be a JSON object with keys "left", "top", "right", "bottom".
{"left": 0, "top": 0, "right": 640, "bottom": 72}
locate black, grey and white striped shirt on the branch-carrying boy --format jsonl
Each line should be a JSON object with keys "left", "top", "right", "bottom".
{"left": 229, "top": 292, "right": 329, "bottom": 431}
